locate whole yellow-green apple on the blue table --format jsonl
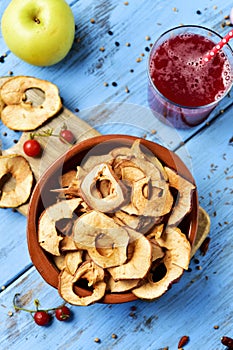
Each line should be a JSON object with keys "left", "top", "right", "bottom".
{"left": 1, "top": 0, "right": 75, "bottom": 66}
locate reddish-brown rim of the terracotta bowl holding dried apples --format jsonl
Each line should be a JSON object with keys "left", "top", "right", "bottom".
{"left": 27, "top": 134, "right": 199, "bottom": 304}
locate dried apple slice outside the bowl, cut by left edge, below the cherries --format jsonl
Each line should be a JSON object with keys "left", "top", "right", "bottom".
{"left": 0, "top": 154, "right": 33, "bottom": 208}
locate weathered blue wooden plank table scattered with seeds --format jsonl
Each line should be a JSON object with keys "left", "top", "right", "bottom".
{"left": 0, "top": 0, "right": 233, "bottom": 350}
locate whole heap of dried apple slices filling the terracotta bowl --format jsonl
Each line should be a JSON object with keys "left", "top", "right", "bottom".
{"left": 38, "top": 139, "right": 195, "bottom": 305}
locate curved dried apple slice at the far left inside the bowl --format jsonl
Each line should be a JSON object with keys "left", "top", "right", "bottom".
{"left": 38, "top": 198, "right": 81, "bottom": 255}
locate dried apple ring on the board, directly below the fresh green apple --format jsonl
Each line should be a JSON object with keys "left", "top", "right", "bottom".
{"left": 0, "top": 76, "right": 62, "bottom": 131}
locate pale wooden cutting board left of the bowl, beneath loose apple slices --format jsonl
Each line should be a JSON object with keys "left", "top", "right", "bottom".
{"left": 0, "top": 77, "right": 99, "bottom": 216}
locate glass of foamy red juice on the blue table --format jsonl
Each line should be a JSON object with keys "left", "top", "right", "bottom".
{"left": 148, "top": 25, "right": 233, "bottom": 128}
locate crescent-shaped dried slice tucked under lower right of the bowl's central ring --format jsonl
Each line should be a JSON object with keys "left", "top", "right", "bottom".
{"left": 108, "top": 229, "right": 152, "bottom": 281}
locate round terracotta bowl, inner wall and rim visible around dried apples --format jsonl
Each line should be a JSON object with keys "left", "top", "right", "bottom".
{"left": 27, "top": 135, "right": 198, "bottom": 304}
